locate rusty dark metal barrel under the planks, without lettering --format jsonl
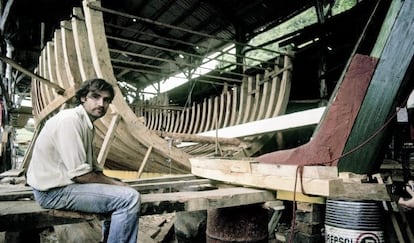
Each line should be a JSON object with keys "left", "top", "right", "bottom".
{"left": 206, "top": 205, "right": 268, "bottom": 243}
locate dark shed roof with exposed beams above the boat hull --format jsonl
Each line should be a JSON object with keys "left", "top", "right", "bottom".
{"left": 9, "top": 0, "right": 315, "bottom": 94}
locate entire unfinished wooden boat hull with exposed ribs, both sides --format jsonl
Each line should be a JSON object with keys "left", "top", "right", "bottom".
{"left": 24, "top": 0, "right": 291, "bottom": 173}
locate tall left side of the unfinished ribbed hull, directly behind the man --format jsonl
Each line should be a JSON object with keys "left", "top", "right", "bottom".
{"left": 25, "top": 2, "right": 190, "bottom": 173}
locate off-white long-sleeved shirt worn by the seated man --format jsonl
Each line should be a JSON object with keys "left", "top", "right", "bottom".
{"left": 27, "top": 105, "right": 102, "bottom": 191}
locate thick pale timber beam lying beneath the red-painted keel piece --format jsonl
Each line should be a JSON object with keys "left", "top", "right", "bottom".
{"left": 190, "top": 158, "right": 390, "bottom": 201}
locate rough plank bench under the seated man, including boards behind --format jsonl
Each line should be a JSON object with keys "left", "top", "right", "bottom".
{"left": 0, "top": 175, "right": 276, "bottom": 232}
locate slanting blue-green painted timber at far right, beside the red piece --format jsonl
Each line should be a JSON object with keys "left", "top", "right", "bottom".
{"left": 339, "top": 1, "right": 414, "bottom": 174}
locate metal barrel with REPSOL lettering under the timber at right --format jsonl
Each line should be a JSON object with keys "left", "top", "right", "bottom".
{"left": 325, "top": 199, "right": 384, "bottom": 243}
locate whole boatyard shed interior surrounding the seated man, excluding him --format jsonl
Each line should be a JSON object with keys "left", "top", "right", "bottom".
{"left": 0, "top": 0, "right": 414, "bottom": 243}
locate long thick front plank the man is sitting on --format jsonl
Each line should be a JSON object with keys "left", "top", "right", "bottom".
{"left": 0, "top": 187, "right": 275, "bottom": 232}
